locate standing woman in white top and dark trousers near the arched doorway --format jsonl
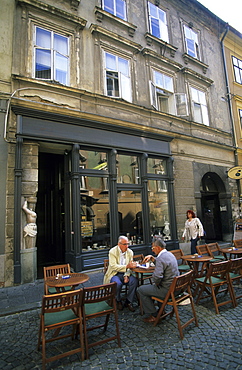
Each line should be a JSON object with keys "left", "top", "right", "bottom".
{"left": 182, "top": 209, "right": 204, "bottom": 254}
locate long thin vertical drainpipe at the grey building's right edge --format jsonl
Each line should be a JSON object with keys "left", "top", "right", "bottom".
{"left": 220, "top": 23, "right": 241, "bottom": 217}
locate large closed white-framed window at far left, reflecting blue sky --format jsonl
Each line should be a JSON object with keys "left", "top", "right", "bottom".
{"left": 34, "top": 27, "right": 69, "bottom": 85}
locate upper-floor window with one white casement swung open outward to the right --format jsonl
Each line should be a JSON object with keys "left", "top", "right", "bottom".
{"left": 150, "top": 70, "right": 188, "bottom": 116}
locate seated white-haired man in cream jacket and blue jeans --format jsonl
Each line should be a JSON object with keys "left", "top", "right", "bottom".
{"left": 103, "top": 236, "right": 138, "bottom": 312}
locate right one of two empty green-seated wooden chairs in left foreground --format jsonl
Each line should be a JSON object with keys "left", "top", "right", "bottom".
{"left": 82, "top": 283, "right": 121, "bottom": 358}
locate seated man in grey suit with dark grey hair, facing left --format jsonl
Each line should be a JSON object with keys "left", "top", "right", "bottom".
{"left": 137, "top": 238, "right": 180, "bottom": 322}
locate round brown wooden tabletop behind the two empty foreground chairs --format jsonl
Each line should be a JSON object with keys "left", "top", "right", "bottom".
{"left": 45, "top": 272, "right": 89, "bottom": 292}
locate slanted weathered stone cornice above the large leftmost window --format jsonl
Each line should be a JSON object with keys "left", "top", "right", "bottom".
{"left": 17, "top": 0, "right": 87, "bottom": 29}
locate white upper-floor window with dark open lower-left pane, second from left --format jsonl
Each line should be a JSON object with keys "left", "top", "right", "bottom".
{"left": 105, "top": 53, "right": 132, "bottom": 102}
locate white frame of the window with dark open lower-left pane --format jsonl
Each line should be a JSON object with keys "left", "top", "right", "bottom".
{"left": 104, "top": 51, "right": 132, "bottom": 103}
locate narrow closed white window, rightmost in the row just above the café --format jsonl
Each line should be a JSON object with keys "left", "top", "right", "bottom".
{"left": 191, "top": 87, "right": 209, "bottom": 126}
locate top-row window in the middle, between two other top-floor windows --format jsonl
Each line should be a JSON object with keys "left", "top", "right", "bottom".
{"left": 148, "top": 2, "right": 169, "bottom": 42}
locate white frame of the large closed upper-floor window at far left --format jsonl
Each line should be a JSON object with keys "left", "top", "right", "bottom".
{"left": 33, "top": 26, "right": 70, "bottom": 85}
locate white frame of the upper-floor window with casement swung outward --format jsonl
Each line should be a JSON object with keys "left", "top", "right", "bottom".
{"left": 149, "top": 70, "right": 188, "bottom": 116}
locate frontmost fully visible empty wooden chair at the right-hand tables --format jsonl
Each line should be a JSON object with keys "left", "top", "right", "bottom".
{"left": 195, "top": 261, "right": 236, "bottom": 314}
